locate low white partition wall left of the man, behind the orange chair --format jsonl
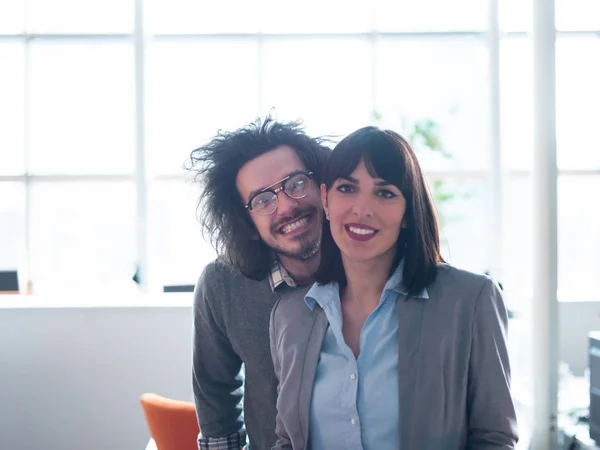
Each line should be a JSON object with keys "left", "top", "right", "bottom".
{"left": 0, "top": 298, "right": 192, "bottom": 450}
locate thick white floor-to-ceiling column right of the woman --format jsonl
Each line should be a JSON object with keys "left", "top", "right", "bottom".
{"left": 531, "top": 0, "right": 558, "bottom": 450}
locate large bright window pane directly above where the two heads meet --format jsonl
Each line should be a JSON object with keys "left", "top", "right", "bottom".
{"left": 261, "top": 38, "right": 373, "bottom": 136}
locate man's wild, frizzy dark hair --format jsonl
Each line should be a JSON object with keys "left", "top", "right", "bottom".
{"left": 184, "top": 117, "right": 331, "bottom": 280}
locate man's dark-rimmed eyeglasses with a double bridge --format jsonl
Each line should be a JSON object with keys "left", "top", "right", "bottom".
{"left": 245, "top": 172, "right": 313, "bottom": 216}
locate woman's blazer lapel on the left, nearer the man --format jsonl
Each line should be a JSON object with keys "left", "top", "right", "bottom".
{"left": 298, "top": 305, "right": 329, "bottom": 448}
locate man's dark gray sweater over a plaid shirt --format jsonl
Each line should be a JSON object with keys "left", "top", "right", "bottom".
{"left": 192, "top": 261, "right": 281, "bottom": 450}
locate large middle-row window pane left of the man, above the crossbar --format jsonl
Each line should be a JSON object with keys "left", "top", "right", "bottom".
{"left": 28, "top": 41, "right": 135, "bottom": 174}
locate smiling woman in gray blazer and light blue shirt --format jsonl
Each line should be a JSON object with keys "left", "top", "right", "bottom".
{"left": 270, "top": 127, "right": 518, "bottom": 450}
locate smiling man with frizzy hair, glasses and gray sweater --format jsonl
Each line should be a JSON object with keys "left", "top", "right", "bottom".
{"left": 188, "top": 118, "right": 329, "bottom": 450}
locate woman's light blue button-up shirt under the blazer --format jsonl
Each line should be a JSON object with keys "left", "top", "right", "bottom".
{"left": 305, "top": 264, "right": 428, "bottom": 450}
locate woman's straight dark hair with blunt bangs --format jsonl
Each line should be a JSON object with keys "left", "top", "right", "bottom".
{"left": 315, "top": 126, "right": 443, "bottom": 295}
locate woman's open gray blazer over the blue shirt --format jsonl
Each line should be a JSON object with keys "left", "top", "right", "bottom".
{"left": 270, "top": 264, "right": 518, "bottom": 450}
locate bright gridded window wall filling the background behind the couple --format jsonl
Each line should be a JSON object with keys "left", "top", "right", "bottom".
{"left": 0, "top": 0, "right": 600, "bottom": 450}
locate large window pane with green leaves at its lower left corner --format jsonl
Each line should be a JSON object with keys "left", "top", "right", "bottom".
{"left": 375, "top": 37, "right": 490, "bottom": 170}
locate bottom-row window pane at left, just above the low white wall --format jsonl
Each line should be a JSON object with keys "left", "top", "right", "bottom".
{"left": 30, "top": 181, "right": 137, "bottom": 294}
